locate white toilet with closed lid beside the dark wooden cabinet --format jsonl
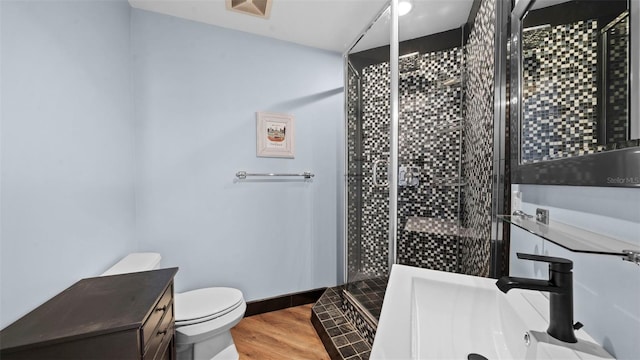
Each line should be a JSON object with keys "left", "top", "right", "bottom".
{"left": 101, "top": 253, "right": 247, "bottom": 360}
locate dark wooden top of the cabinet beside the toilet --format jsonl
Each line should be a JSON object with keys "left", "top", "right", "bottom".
{"left": 0, "top": 268, "right": 178, "bottom": 355}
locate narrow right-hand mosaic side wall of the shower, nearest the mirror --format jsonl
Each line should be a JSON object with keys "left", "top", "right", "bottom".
{"left": 460, "top": 0, "right": 496, "bottom": 276}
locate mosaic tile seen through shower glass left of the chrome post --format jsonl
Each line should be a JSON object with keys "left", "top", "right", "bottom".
{"left": 347, "top": 57, "right": 389, "bottom": 282}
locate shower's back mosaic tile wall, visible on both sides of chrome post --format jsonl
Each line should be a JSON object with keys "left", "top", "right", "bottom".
{"left": 362, "top": 48, "right": 462, "bottom": 272}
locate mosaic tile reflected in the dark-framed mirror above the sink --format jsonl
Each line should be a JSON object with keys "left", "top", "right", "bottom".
{"left": 522, "top": 20, "right": 604, "bottom": 163}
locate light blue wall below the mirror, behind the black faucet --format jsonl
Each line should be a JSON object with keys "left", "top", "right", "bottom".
{"left": 510, "top": 185, "right": 640, "bottom": 359}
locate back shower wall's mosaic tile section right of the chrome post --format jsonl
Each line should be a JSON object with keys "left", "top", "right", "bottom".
{"left": 398, "top": 47, "right": 463, "bottom": 272}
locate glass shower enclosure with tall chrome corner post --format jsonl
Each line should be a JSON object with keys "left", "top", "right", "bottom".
{"left": 344, "top": 0, "right": 465, "bottom": 326}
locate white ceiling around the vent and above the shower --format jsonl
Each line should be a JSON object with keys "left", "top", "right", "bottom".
{"left": 129, "top": 0, "right": 473, "bottom": 53}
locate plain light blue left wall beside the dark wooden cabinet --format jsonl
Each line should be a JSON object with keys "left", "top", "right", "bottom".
{"left": 0, "top": 0, "right": 135, "bottom": 327}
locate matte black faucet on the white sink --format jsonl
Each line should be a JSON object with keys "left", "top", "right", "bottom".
{"left": 496, "top": 253, "right": 582, "bottom": 343}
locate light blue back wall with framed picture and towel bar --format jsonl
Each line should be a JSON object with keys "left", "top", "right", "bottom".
{"left": 132, "top": 10, "right": 344, "bottom": 300}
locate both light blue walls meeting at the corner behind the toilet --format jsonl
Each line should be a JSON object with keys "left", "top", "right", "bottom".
{"left": 0, "top": 0, "right": 343, "bottom": 327}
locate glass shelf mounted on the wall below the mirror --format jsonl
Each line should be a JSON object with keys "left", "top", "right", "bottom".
{"left": 498, "top": 215, "right": 640, "bottom": 263}
